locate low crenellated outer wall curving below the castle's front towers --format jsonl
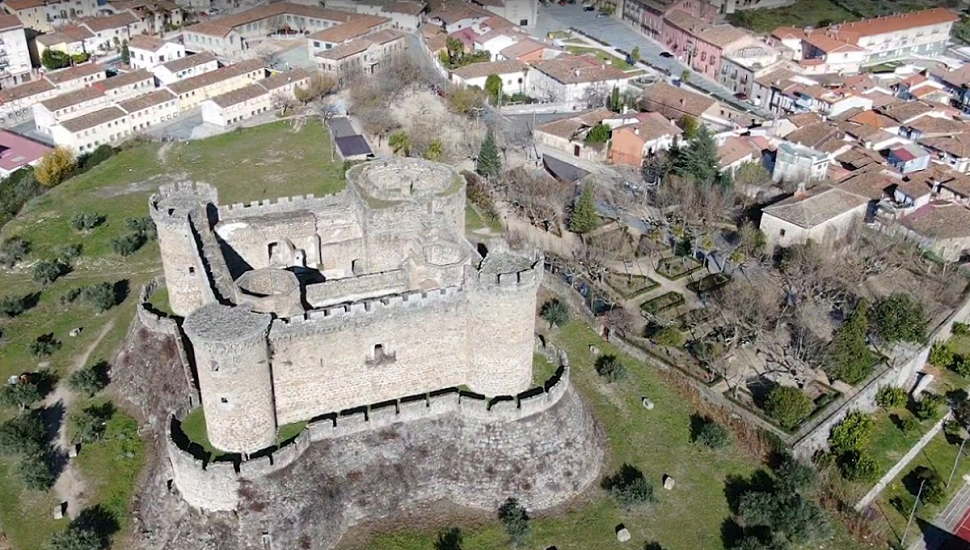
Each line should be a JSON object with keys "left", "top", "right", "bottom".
{"left": 165, "top": 352, "right": 570, "bottom": 511}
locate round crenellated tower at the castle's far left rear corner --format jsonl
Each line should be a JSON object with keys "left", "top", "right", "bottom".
{"left": 148, "top": 182, "right": 217, "bottom": 317}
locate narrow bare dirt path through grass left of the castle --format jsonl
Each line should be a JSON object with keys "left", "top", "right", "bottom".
{"left": 43, "top": 319, "right": 115, "bottom": 519}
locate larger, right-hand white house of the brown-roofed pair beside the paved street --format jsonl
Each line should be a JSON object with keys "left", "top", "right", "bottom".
{"left": 529, "top": 55, "right": 633, "bottom": 108}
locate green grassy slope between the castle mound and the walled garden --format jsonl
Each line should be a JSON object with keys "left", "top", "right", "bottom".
{"left": 358, "top": 321, "right": 758, "bottom": 550}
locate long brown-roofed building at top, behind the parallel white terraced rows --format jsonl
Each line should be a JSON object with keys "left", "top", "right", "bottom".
{"left": 182, "top": 2, "right": 357, "bottom": 57}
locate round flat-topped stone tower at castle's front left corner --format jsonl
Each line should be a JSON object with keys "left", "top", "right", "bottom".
{"left": 182, "top": 304, "right": 276, "bottom": 453}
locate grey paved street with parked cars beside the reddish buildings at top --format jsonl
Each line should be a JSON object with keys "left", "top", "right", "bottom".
{"left": 532, "top": 3, "right": 771, "bottom": 118}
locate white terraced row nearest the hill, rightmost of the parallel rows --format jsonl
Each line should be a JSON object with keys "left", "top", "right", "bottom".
{"left": 202, "top": 69, "right": 310, "bottom": 126}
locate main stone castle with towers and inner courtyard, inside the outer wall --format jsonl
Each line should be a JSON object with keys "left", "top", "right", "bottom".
{"left": 150, "top": 159, "right": 542, "bottom": 453}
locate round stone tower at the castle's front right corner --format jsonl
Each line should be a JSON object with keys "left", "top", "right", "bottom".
{"left": 467, "top": 243, "right": 542, "bottom": 395}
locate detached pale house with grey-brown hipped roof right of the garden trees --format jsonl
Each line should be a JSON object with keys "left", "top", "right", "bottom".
{"left": 760, "top": 186, "right": 869, "bottom": 250}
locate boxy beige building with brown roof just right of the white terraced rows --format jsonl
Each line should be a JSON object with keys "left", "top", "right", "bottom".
{"left": 315, "top": 29, "right": 407, "bottom": 80}
